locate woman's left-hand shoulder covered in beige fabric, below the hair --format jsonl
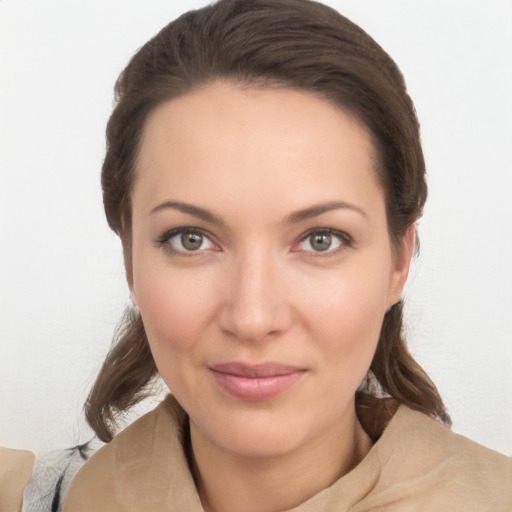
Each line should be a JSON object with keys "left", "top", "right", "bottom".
{"left": 63, "top": 398, "right": 201, "bottom": 512}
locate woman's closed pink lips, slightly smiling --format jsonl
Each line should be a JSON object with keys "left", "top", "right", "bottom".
{"left": 209, "top": 363, "right": 306, "bottom": 401}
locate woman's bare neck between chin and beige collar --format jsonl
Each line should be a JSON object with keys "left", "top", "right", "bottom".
{"left": 191, "top": 413, "right": 371, "bottom": 512}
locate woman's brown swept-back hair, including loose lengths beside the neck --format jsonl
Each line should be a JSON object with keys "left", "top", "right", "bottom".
{"left": 86, "top": 0, "right": 450, "bottom": 441}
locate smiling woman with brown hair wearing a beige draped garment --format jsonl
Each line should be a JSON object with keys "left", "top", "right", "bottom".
{"left": 8, "top": 0, "right": 512, "bottom": 511}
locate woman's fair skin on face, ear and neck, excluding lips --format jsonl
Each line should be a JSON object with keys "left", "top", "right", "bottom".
{"left": 128, "top": 82, "right": 414, "bottom": 512}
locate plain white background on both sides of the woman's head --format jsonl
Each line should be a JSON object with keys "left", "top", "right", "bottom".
{"left": 0, "top": 0, "right": 512, "bottom": 455}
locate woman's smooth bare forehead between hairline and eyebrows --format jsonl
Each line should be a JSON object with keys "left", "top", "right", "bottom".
{"left": 134, "top": 82, "right": 377, "bottom": 216}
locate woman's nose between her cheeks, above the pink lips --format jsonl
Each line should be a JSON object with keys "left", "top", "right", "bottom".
{"left": 218, "top": 249, "right": 293, "bottom": 342}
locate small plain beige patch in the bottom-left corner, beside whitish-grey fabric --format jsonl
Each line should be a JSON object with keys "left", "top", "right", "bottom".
{"left": 0, "top": 446, "right": 34, "bottom": 512}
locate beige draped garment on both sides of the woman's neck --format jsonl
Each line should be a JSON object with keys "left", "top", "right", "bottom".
{"left": 58, "top": 397, "right": 512, "bottom": 512}
